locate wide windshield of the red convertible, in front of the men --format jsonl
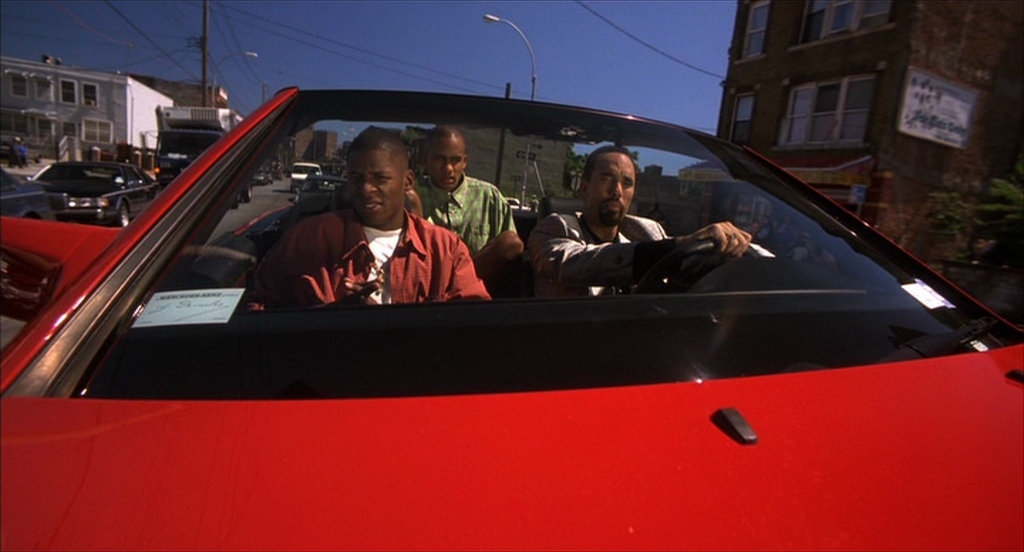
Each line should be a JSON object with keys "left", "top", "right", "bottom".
{"left": 66, "top": 92, "right": 1015, "bottom": 398}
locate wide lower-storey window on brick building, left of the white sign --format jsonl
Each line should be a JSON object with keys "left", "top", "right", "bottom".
{"left": 779, "top": 77, "right": 874, "bottom": 145}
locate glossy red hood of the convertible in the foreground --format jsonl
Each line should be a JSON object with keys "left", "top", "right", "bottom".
{"left": 0, "top": 346, "right": 1024, "bottom": 550}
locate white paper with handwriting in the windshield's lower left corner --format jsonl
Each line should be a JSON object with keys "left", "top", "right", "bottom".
{"left": 132, "top": 288, "right": 246, "bottom": 328}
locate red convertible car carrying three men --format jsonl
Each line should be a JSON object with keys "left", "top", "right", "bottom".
{"left": 0, "top": 89, "right": 1024, "bottom": 550}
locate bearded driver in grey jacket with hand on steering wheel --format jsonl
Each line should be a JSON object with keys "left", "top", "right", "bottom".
{"left": 527, "top": 145, "right": 751, "bottom": 297}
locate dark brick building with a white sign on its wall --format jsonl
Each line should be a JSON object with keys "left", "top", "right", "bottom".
{"left": 718, "top": 0, "right": 1024, "bottom": 260}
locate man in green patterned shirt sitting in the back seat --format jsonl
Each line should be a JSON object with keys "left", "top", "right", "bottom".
{"left": 412, "top": 125, "right": 523, "bottom": 290}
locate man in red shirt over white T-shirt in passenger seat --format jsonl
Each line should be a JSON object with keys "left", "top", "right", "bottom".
{"left": 253, "top": 127, "right": 490, "bottom": 307}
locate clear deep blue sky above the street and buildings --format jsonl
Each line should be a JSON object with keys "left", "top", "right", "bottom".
{"left": 0, "top": 0, "right": 736, "bottom": 133}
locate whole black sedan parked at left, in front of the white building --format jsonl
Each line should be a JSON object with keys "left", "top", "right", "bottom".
{"left": 31, "top": 161, "right": 160, "bottom": 226}
